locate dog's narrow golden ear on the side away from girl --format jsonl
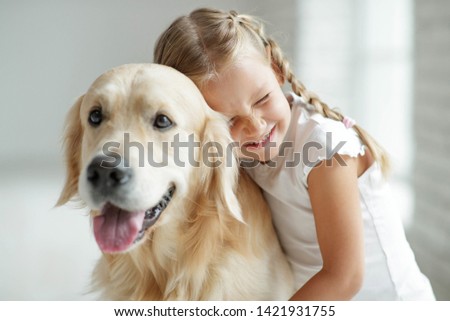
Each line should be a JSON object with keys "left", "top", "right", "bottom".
{"left": 56, "top": 95, "right": 84, "bottom": 206}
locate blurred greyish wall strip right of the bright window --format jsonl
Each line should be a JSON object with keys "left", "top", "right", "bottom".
{"left": 410, "top": 0, "right": 450, "bottom": 300}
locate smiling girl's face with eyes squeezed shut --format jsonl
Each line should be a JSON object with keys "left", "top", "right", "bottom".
{"left": 201, "top": 55, "right": 291, "bottom": 162}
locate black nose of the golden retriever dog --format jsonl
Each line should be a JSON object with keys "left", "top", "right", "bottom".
{"left": 87, "top": 156, "right": 132, "bottom": 188}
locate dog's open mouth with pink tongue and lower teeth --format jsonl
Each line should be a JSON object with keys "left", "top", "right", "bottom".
{"left": 93, "top": 185, "right": 175, "bottom": 253}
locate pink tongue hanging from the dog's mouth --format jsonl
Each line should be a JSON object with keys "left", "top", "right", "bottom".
{"left": 94, "top": 203, "right": 145, "bottom": 253}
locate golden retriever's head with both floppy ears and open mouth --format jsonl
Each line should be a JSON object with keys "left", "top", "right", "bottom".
{"left": 57, "top": 64, "right": 241, "bottom": 252}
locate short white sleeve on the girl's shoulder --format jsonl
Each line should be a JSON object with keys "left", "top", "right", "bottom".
{"left": 298, "top": 115, "right": 365, "bottom": 187}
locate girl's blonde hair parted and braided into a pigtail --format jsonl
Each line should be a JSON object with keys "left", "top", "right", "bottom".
{"left": 153, "top": 8, "right": 389, "bottom": 174}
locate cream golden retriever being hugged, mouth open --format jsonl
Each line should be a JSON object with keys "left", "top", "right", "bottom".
{"left": 57, "top": 64, "right": 294, "bottom": 300}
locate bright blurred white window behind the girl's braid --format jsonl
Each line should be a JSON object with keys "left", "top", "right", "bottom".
{"left": 294, "top": 0, "right": 413, "bottom": 225}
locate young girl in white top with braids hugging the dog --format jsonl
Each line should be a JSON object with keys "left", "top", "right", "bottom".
{"left": 154, "top": 9, "right": 434, "bottom": 300}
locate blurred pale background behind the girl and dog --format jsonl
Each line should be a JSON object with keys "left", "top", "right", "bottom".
{"left": 0, "top": 0, "right": 450, "bottom": 300}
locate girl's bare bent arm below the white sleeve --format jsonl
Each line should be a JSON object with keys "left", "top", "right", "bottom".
{"left": 291, "top": 155, "right": 365, "bottom": 300}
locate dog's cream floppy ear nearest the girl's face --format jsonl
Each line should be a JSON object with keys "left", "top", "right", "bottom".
{"left": 200, "top": 110, "right": 244, "bottom": 222}
